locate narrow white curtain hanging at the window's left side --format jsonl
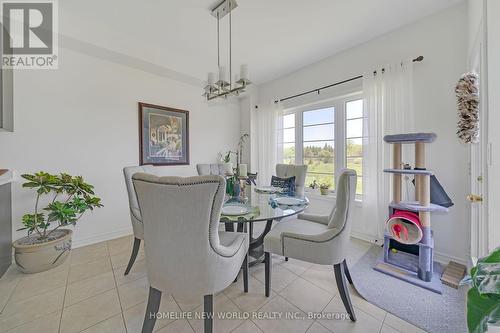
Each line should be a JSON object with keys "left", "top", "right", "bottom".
{"left": 256, "top": 102, "right": 283, "bottom": 186}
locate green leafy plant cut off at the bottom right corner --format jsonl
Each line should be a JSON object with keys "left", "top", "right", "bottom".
{"left": 462, "top": 247, "right": 500, "bottom": 333}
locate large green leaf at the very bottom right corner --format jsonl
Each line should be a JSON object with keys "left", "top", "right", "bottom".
{"left": 467, "top": 288, "right": 500, "bottom": 333}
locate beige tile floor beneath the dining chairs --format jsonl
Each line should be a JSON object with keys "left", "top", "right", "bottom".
{"left": 0, "top": 237, "right": 430, "bottom": 333}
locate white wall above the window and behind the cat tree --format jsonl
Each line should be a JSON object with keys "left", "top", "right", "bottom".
{"left": 254, "top": 3, "right": 469, "bottom": 262}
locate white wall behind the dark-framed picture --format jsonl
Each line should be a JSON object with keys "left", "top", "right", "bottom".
{"left": 0, "top": 48, "right": 240, "bottom": 245}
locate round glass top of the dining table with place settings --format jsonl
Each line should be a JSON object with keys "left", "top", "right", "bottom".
{"left": 220, "top": 185, "right": 309, "bottom": 223}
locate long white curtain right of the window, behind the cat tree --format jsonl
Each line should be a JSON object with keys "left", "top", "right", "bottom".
{"left": 362, "top": 60, "right": 414, "bottom": 239}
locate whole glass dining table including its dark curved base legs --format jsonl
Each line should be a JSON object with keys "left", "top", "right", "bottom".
{"left": 220, "top": 185, "right": 309, "bottom": 266}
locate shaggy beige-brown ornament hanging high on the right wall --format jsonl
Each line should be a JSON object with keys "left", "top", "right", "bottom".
{"left": 455, "top": 73, "right": 479, "bottom": 143}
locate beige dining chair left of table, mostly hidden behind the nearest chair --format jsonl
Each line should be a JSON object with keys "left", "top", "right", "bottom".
{"left": 123, "top": 165, "right": 171, "bottom": 275}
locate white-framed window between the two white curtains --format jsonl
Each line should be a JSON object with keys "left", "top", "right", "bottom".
{"left": 279, "top": 92, "right": 364, "bottom": 197}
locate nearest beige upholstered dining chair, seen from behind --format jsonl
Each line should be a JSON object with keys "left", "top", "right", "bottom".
{"left": 132, "top": 173, "right": 249, "bottom": 333}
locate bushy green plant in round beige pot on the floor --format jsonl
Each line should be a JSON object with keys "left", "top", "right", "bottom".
{"left": 13, "top": 172, "right": 102, "bottom": 273}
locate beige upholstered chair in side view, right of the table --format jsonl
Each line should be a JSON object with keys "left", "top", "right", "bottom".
{"left": 264, "top": 169, "right": 357, "bottom": 321}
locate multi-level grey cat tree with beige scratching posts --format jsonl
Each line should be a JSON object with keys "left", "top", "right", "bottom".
{"left": 374, "top": 133, "right": 448, "bottom": 293}
